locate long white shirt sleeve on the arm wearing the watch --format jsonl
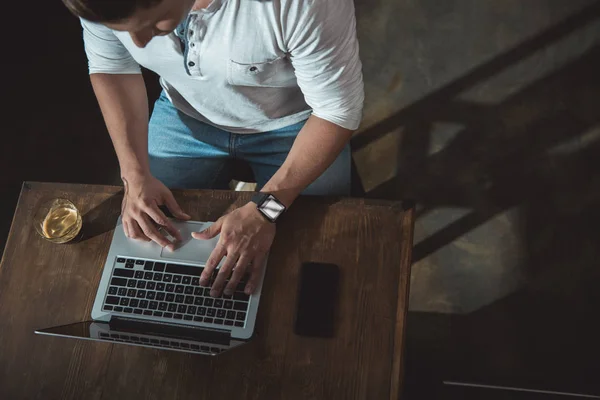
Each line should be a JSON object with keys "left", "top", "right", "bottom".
{"left": 281, "top": 0, "right": 364, "bottom": 130}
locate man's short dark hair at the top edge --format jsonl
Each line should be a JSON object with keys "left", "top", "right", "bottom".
{"left": 62, "top": 0, "right": 162, "bottom": 22}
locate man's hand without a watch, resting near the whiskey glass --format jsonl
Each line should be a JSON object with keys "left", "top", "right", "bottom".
{"left": 121, "top": 174, "right": 190, "bottom": 250}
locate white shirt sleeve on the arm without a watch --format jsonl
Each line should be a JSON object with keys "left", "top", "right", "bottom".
{"left": 81, "top": 19, "right": 141, "bottom": 74}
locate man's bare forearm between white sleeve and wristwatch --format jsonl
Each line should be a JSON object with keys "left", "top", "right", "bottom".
{"left": 261, "top": 116, "right": 352, "bottom": 207}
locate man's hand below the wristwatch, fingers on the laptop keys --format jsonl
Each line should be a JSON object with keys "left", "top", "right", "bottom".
{"left": 192, "top": 203, "right": 275, "bottom": 297}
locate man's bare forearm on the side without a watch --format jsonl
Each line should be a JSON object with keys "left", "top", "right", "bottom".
{"left": 90, "top": 74, "right": 149, "bottom": 177}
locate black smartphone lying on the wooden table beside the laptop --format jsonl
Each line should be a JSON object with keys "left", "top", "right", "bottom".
{"left": 294, "top": 262, "right": 340, "bottom": 337}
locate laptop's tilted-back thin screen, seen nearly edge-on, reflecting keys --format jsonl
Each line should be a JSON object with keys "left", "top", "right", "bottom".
{"left": 35, "top": 321, "right": 246, "bottom": 355}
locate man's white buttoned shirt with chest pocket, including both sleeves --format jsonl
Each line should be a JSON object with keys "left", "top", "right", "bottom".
{"left": 82, "top": 0, "right": 364, "bottom": 133}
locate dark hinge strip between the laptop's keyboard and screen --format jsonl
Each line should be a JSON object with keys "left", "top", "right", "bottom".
{"left": 108, "top": 317, "right": 231, "bottom": 345}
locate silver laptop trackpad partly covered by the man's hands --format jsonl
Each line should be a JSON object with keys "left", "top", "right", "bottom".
{"left": 160, "top": 222, "right": 219, "bottom": 264}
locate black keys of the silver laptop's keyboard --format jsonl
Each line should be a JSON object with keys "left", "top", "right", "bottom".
{"left": 102, "top": 257, "right": 250, "bottom": 328}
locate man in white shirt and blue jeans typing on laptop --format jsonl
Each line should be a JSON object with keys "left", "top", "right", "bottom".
{"left": 63, "top": 0, "right": 363, "bottom": 296}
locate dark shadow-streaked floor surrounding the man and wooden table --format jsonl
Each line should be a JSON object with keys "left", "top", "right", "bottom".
{"left": 0, "top": 0, "right": 600, "bottom": 399}
